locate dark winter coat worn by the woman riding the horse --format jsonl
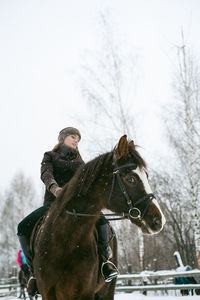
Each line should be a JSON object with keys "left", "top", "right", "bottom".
{"left": 41, "top": 144, "right": 84, "bottom": 205}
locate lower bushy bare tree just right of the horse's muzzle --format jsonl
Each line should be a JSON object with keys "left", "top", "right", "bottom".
{"left": 150, "top": 171, "right": 197, "bottom": 268}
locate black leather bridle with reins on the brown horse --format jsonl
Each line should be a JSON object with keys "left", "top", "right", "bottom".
{"left": 66, "top": 155, "right": 155, "bottom": 221}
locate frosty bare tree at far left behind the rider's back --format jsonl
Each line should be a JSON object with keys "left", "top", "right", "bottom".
{"left": 0, "top": 173, "right": 36, "bottom": 272}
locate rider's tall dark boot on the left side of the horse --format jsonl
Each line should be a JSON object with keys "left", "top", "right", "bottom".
{"left": 18, "top": 235, "right": 38, "bottom": 296}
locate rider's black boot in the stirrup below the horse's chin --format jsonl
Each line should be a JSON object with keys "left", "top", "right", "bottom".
{"left": 97, "top": 223, "right": 119, "bottom": 282}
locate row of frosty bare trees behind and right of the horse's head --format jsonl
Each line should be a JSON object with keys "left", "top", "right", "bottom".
{"left": 78, "top": 16, "right": 200, "bottom": 271}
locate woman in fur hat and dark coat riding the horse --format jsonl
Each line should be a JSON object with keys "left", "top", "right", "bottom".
{"left": 18, "top": 127, "right": 118, "bottom": 295}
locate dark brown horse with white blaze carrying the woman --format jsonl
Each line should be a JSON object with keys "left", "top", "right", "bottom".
{"left": 33, "top": 135, "right": 165, "bottom": 300}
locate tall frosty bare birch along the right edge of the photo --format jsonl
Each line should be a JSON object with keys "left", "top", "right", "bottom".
{"left": 167, "top": 34, "right": 200, "bottom": 264}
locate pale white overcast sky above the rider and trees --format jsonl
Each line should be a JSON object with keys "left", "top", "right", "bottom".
{"left": 0, "top": 0, "right": 200, "bottom": 196}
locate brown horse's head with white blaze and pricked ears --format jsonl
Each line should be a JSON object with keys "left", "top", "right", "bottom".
{"left": 108, "top": 135, "right": 165, "bottom": 234}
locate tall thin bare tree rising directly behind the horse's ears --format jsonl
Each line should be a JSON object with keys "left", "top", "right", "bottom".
{"left": 78, "top": 14, "right": 147, "bottom": 269}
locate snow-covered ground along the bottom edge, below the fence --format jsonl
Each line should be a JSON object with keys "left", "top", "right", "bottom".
{"left": 1, "top": 293, "right": 200, "bottom": 300}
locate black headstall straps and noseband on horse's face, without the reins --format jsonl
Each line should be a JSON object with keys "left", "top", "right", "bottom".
{"left": 108, "top": 157, "right": 155, "bottom": 221}
